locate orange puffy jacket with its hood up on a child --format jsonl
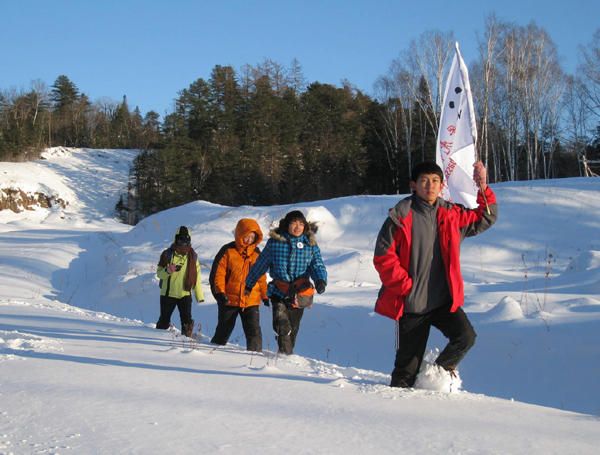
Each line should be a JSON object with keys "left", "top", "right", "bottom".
{"left": 208, "top": 218, "right": 267, "bottom": 308}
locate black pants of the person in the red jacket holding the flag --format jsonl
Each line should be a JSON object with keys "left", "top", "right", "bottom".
{"left": 390, "top": 305, "right": 477, "bottom": 387}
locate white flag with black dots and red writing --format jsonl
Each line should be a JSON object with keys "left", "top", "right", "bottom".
{"left": 436, "top": 43, "right": 477, "bottom": 208}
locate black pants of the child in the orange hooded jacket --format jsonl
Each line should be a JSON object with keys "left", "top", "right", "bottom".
{"left": 210, "top": 305, "right": 262, "bottom": 352}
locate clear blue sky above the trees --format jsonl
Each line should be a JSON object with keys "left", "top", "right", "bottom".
{"left": 0, "top": 0, "right": 600, "bottom": 118}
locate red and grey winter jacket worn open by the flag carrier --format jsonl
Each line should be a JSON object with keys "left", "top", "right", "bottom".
{"left": 373, "top": 186, "right": 498, "bottom": 320}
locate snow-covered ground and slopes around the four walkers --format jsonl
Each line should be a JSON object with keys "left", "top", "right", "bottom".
{"left": 0, "top": 149, "right": 600, "bottom": 454}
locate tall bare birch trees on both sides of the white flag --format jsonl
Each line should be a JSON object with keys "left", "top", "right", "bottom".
{"left": 375, "top": 14, "right": 600, "bottom": 187}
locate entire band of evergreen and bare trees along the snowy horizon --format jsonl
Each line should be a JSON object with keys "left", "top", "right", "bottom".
{"left": 0, "top": 14, "right": 600, "bottom": 223}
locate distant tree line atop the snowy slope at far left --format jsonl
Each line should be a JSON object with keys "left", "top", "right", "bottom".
{"left": 0, "top": 75, "right": 160, "bottom": 161}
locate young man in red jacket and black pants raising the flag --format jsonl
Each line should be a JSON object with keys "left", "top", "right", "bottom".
{"left": 373, "top": 162, "right": 498, "bottom": 387}
